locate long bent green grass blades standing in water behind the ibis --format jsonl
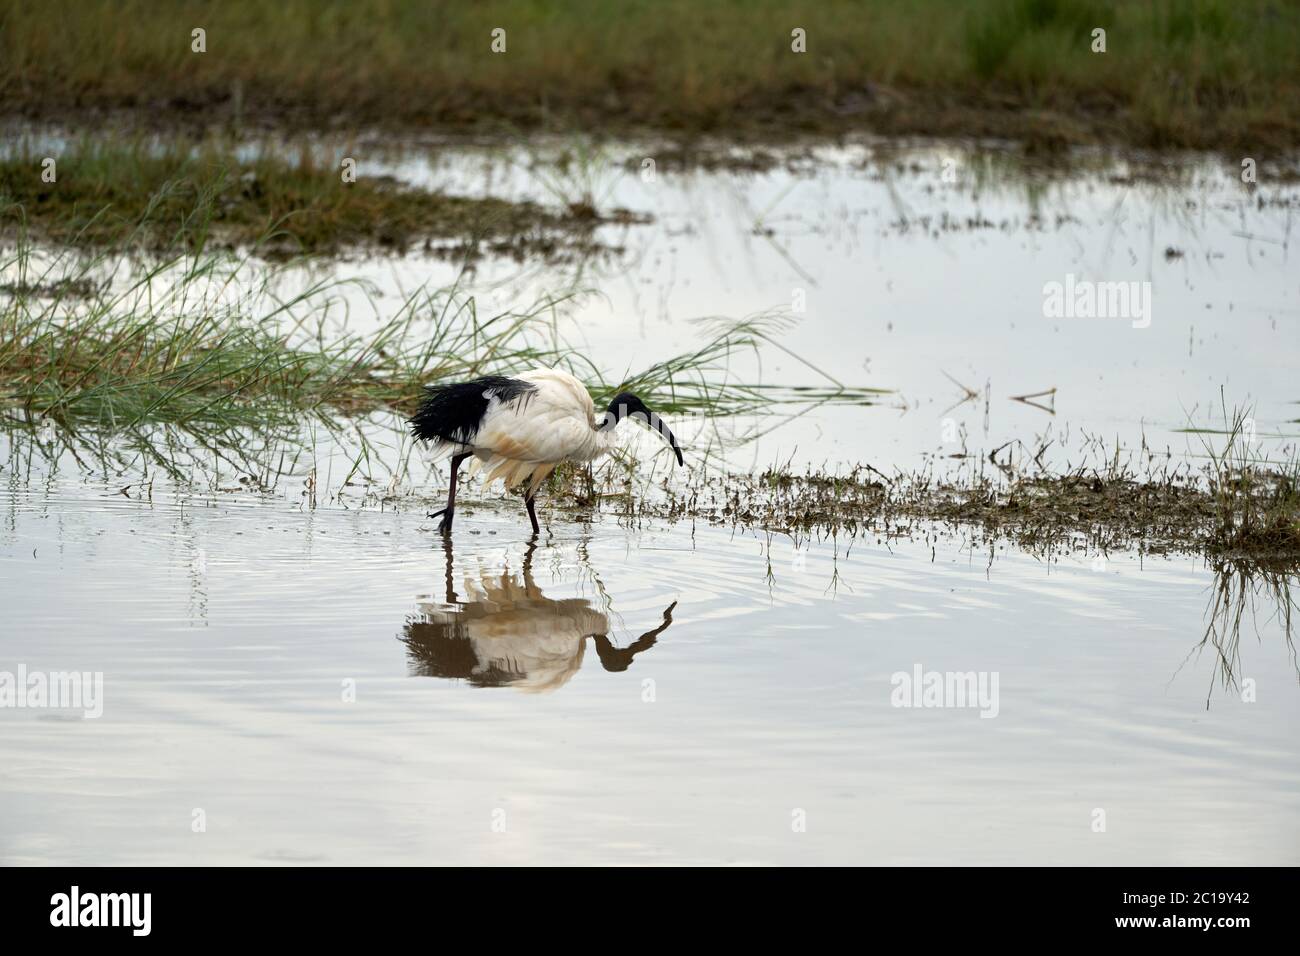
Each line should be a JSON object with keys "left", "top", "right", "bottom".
{"left": 0, "top": 230, "right": 870, "bottom": 431}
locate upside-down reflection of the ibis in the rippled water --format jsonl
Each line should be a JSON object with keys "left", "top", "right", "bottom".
{"left": 402, "top": 538, "right": 677, "bottom": 691}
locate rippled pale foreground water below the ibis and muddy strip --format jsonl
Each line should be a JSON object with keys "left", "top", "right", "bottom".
{"left": 0, "top": 479, "right": 1300, "bottom": 865}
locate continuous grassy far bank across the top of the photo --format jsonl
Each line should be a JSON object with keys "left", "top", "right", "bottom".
{"left": 0, "top": 0, "right": 1300, "bottom": 148}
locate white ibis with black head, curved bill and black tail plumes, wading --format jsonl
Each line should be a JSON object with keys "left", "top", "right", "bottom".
{"left": 411, "top": 368, "right": 683, "bottom": 535}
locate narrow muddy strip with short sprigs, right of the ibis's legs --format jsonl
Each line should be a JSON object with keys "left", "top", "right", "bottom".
{"left": 530, "top": 455, "right": 1300, "bottom": 571}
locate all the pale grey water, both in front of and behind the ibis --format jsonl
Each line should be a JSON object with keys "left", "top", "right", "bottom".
{"left": 0, "top": 146, "right": 1300, "bottom": 865}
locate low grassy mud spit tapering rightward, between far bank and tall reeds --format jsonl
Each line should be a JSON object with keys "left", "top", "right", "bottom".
{"left": 0, "top": 138, "right": 599, "bottom": 255}
